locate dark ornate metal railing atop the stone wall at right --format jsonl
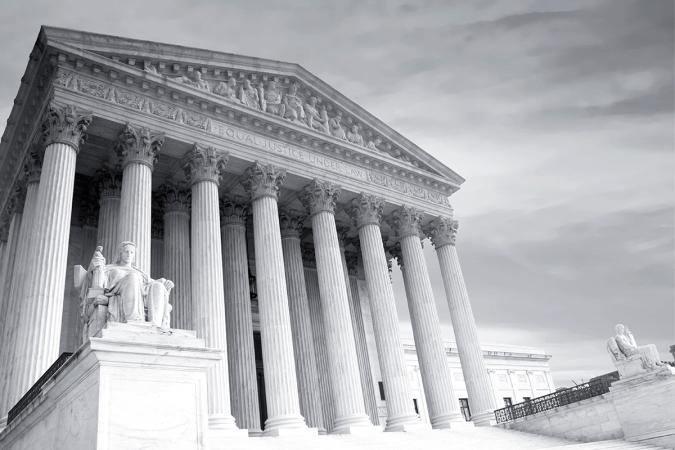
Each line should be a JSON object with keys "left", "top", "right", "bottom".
{"left": 495, "top": 378, "right": 613, "bottom": 423}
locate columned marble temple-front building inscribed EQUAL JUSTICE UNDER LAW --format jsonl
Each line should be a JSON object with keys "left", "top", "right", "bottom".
{"left": 0, "top": 27, "right": 504, "bottom": 440}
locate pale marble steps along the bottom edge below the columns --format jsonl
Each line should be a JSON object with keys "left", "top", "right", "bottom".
{"left": 209, "top": 427, "right": 672, "bottom": 450}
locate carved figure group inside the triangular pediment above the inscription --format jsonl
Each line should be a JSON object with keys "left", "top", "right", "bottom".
{"left": 145, "top": 65, "right": 390, "bottom": 156}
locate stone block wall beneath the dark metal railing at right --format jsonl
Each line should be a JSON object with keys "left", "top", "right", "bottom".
{"left": 502, "top": 394, "right": 624, "bottom": 442}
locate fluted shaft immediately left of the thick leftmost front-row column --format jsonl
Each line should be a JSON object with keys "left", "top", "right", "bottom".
{"left": 0, "top": 183, "right": 38, "bottom": 422}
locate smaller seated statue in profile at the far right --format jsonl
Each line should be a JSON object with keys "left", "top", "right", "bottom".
{"left": 607, "top": 324, "right": 663, "bottom": 378}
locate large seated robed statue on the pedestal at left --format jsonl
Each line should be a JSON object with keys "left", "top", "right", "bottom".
{"left": 80, "top": 241, "right": 174, "bottom": 340}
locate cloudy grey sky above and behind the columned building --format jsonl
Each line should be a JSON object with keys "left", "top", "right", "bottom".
{"left": 0, "top": 0, "right": 675, "bottom": 386}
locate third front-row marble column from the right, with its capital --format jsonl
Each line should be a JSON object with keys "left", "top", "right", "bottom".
{"left": 352, "top": 194, "right": 421, "bottom": 431}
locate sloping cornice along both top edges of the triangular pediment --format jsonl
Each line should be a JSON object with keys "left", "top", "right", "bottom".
{"left": 40, "top": 27, "right": 464, "bottom": 185}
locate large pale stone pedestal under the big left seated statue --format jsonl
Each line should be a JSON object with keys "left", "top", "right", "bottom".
{"left": 0, "top": 323, "right": 222, "bottom": 450}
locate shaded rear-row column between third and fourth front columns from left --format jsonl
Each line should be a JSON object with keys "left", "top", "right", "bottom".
{"left": 220, "top": 199, "right": 261, "bottom": 435}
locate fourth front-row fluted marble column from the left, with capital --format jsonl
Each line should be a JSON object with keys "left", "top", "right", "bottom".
{"left": 244, "top": 162, "right": 309, "bottom": 435}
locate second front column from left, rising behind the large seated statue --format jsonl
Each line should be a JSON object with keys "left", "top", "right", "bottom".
{"left": 116, "top": 123, "right": 164, "bottom": 274}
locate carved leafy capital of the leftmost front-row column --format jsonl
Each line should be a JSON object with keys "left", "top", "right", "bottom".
{"left": 42, "top": 102, "right": 91, "bottom": 150}
